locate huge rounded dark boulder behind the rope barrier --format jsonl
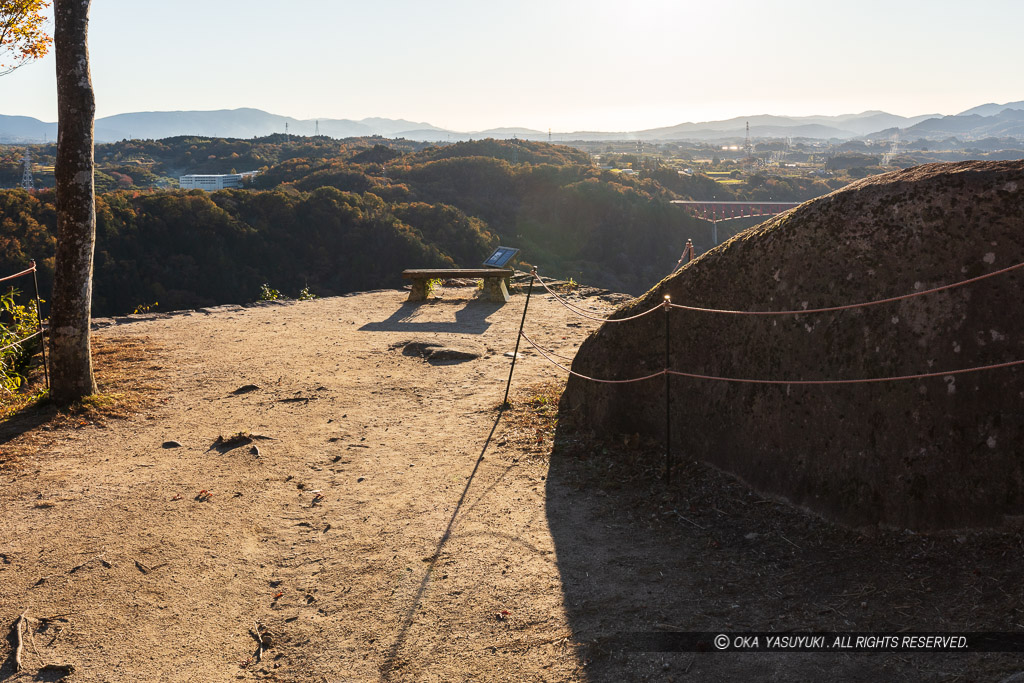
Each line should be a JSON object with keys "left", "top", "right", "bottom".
{"left": 563, "top": 162, "right": 1024, "bottom": 529}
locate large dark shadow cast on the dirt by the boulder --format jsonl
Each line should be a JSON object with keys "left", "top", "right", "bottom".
{"left": 547, "top": 414, "right": 1024, "bottom": 681}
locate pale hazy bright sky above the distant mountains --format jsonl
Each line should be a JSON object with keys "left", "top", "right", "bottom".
{"left": 0, "top": 0, "right": 1024, "bottom": 131}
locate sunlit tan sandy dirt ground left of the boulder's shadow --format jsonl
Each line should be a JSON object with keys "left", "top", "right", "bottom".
{"left": 0, "top": 290, "right": 610, "bottom": 681}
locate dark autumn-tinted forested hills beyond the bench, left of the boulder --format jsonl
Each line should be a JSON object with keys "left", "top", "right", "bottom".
{"left": 0, "top": 135, "right": 702, "bottom": 315}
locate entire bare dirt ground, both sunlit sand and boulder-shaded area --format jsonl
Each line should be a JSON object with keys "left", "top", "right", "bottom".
{"left": 0, "top": 289, "right": 1024, "bottom": 683}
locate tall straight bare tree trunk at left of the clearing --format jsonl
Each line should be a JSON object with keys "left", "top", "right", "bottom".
{"left": 50, "top": 0, "right": 96, "bottom": 404}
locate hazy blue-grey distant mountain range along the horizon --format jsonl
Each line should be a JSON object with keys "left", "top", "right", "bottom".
{"left": 0, "top": 100, "right": 1024, "bottom": 143}
